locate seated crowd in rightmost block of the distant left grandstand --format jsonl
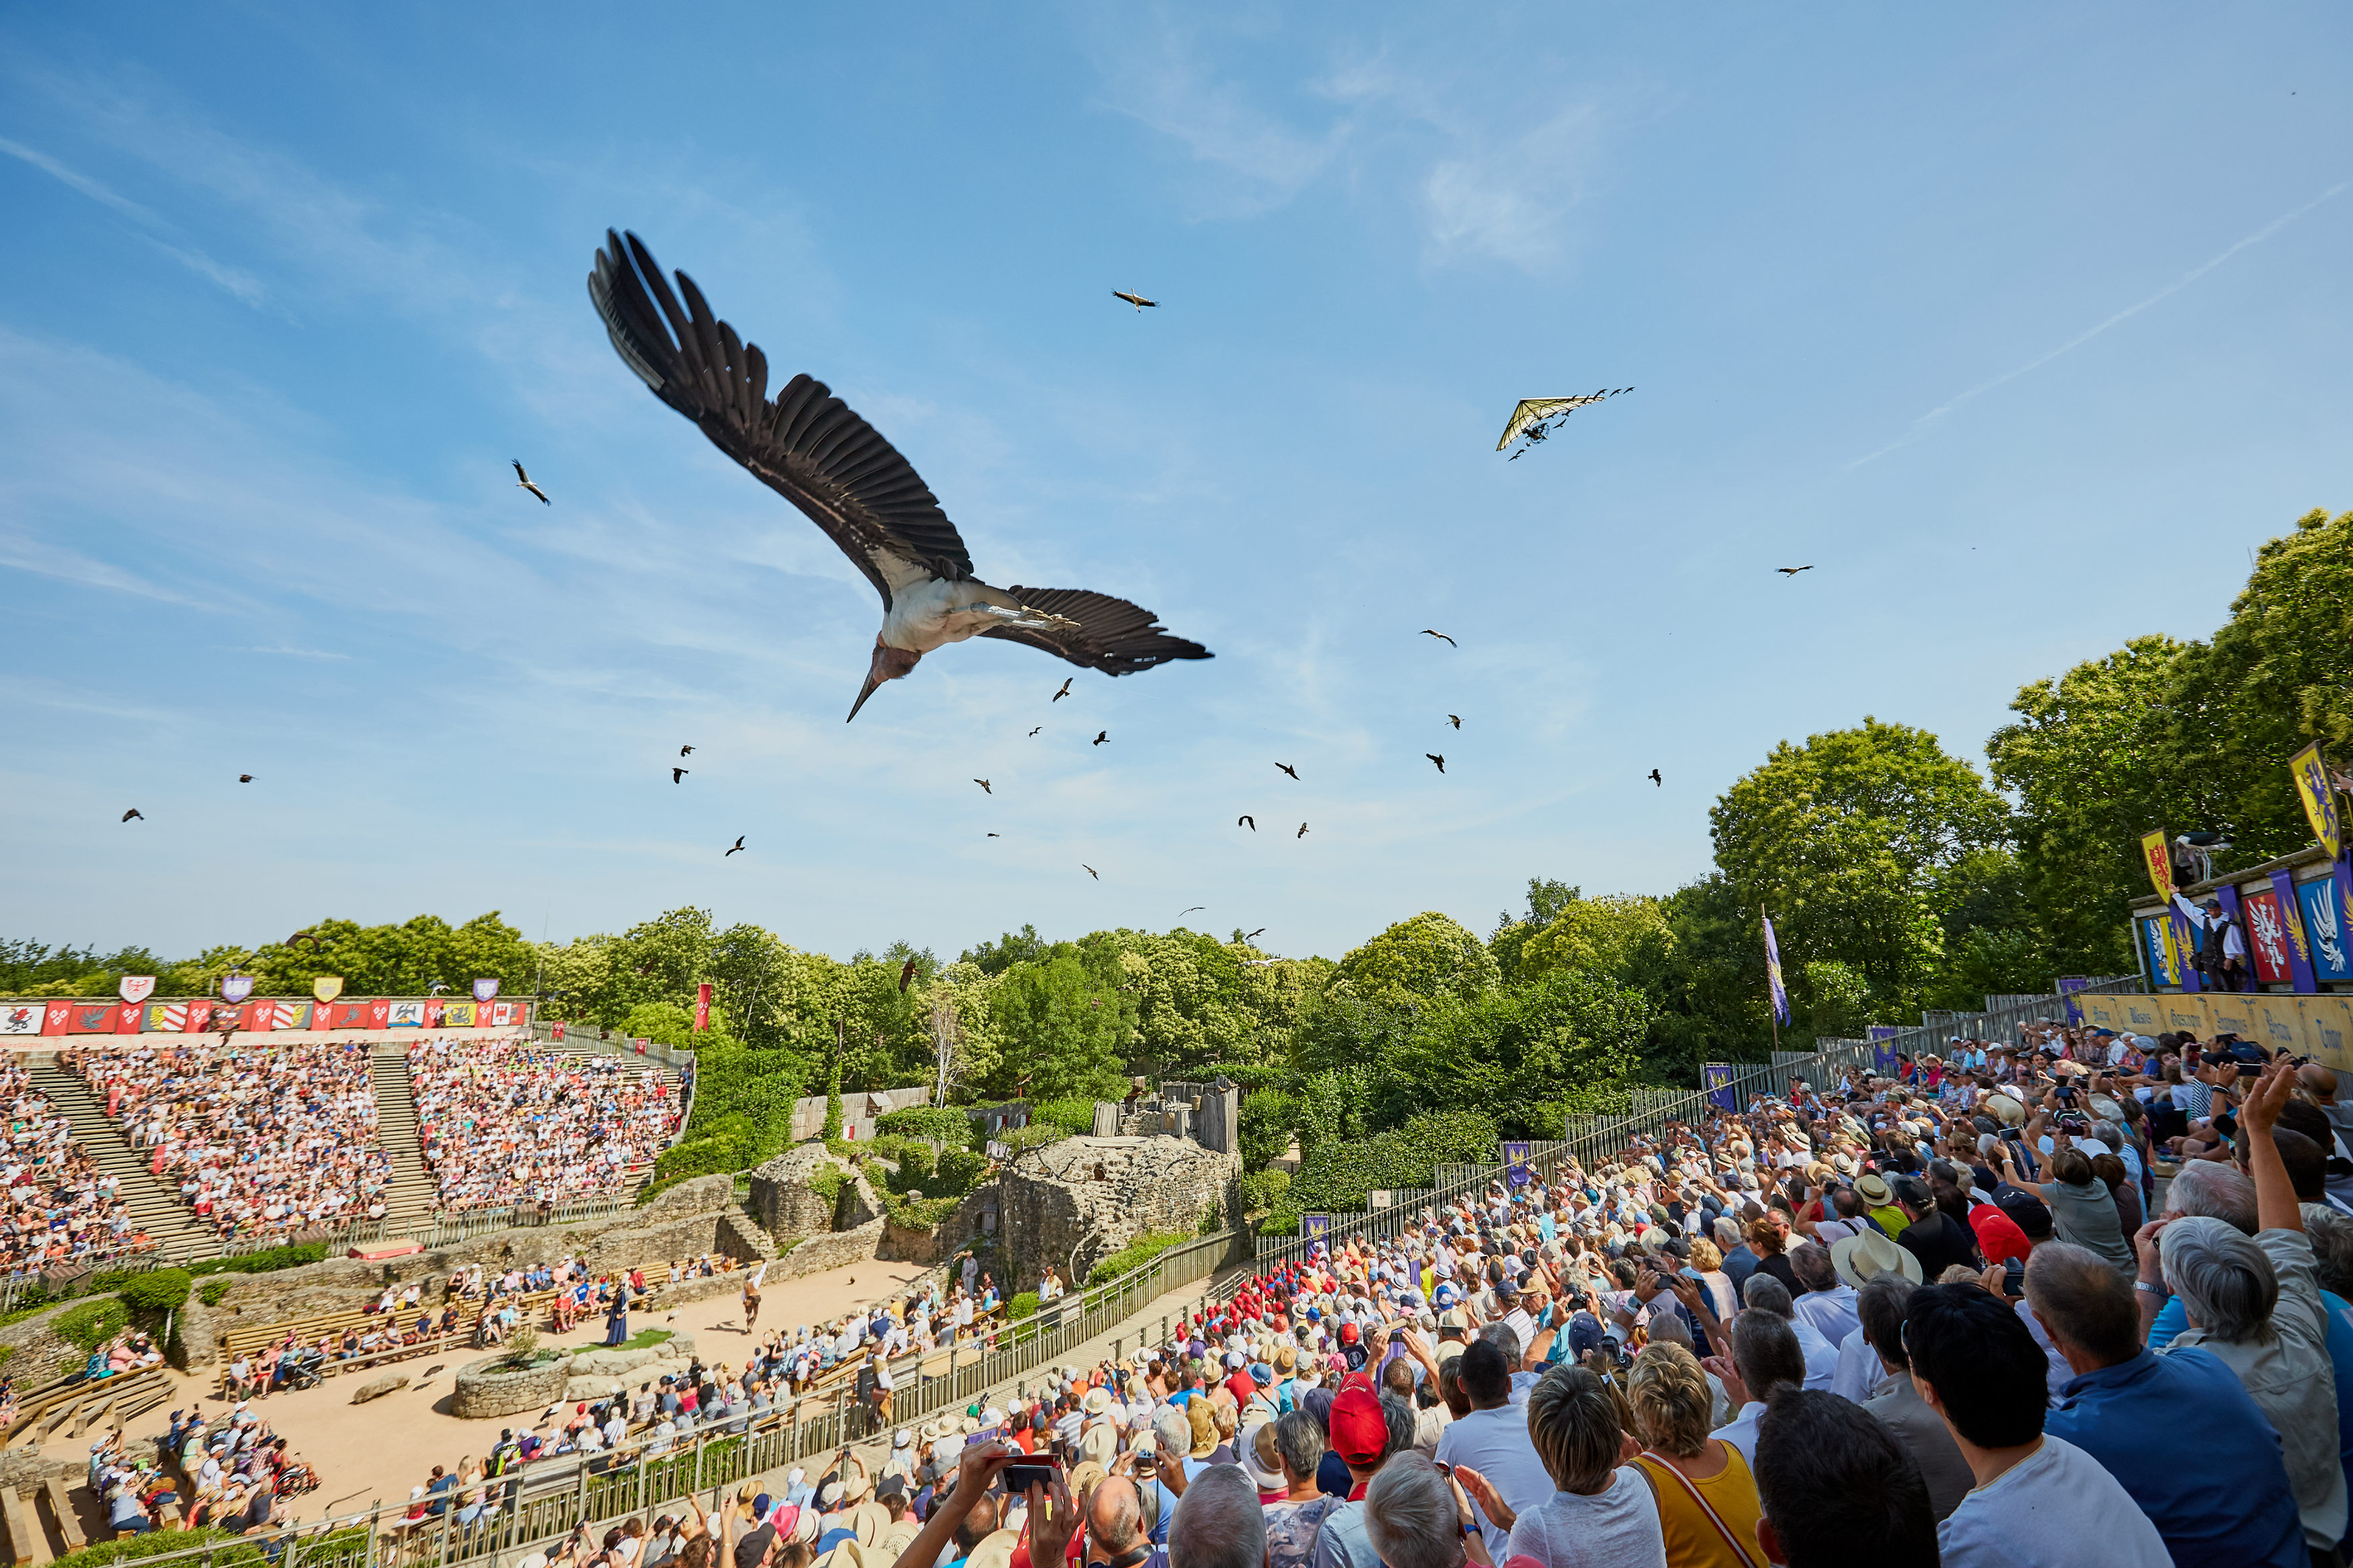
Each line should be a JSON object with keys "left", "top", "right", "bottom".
{"left": 409, "top": 1039, "right": 680, "bottom": 1208}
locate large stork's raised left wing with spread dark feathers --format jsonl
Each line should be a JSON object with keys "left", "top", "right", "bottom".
{"left": 588, "top": 228, "right": 972, "bottom": 606}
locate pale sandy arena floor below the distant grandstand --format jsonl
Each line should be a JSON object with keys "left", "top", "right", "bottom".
{"left": 141, "top": 1260, "right": 925, "bottom": 1519}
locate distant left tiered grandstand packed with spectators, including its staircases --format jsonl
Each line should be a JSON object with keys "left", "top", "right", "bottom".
{"left": 0, "top": 1034, "right": 685, "bottom": 1276}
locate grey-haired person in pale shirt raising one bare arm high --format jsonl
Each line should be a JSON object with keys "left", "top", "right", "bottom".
{"left": 2137, "top": 1063, "right": 2346, "bottom": 1554}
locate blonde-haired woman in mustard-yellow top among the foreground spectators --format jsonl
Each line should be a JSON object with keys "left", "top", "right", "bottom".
{"left": 1626, "top": 1340, "right": 1765, "bottom": 1568}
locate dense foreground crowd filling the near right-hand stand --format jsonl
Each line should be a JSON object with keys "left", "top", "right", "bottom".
{"left": 795, "top": 1028, "right": 2353, "bottom": 1568}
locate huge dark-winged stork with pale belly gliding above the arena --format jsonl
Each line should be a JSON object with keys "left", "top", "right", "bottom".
{"left": 588, "top": 231, "right": 1209, "bottom": 719}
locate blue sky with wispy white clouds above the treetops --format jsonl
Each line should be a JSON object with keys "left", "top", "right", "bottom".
{"left": 0, "top": 5, "right": 2353, "bottom": 954}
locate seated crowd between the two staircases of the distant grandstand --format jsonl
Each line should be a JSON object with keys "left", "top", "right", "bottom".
{"left": 59, "top": 1037, "right": 389, "bottom": 1239}
